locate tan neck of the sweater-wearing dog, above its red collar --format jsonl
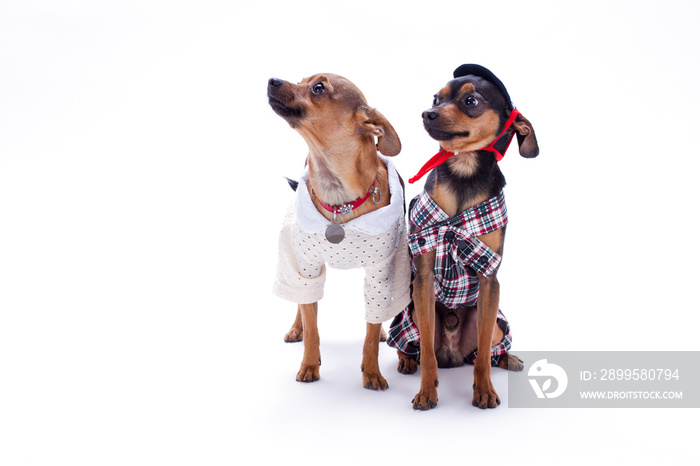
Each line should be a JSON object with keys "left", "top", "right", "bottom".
{"left": 308, "top": 147, "right": 382, "bottom": 206}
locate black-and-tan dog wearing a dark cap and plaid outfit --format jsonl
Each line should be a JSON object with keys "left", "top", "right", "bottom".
{"left": 389, "top": 65, "right": 539, "bottom": 410}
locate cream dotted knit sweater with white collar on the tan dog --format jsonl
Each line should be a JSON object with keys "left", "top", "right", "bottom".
{"left": 273, "top": 158, "right": 411, "bottom": 323}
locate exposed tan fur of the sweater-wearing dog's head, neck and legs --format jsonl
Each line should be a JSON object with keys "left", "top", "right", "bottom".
{"left": 268, "top": 73, "right": 401, "bottom": 390}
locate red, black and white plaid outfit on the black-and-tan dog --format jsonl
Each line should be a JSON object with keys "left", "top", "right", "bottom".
{"left": 387, "top": 191, "right": 512, "bottom": 365}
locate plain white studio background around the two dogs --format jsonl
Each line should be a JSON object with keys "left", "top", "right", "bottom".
{"left": 0, "top": 0, "right": 700, "bottom": 465}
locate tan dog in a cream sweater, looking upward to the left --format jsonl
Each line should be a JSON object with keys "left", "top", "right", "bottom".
{"left": 267, "top": 73, "right": 410, "bottom": 390}
